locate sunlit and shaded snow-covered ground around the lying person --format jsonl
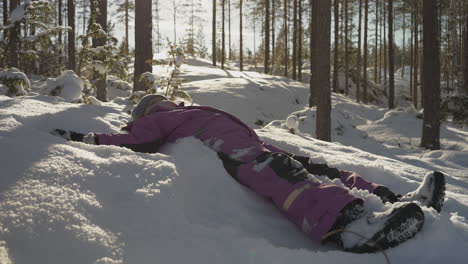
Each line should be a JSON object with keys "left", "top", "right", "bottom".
{"left": 0, "top": 60, "right": 468, "bottom": 264}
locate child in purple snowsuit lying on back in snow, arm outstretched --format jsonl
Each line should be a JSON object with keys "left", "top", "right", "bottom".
{"left": 52, "top": 95, "right": 445, "bottom": 252}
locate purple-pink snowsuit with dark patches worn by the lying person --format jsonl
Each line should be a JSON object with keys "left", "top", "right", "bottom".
{"left": 96, "top": 106, "right": 378, "bottom": 241}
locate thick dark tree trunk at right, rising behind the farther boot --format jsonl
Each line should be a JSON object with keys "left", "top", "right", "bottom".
{"left": 421, "top": 0, "right": 440, "bottom": 150}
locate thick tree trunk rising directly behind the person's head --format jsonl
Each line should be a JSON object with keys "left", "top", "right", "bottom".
{"left": 133, "top": 0, "right": 153, "bottom": 91}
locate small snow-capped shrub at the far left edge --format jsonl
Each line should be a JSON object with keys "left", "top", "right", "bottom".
{"left": 0, "top": 68, "right": 31, "bottom": 96}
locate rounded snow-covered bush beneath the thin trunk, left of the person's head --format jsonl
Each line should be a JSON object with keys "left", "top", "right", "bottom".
{"left": 46, "top": 71, "right": 84, "bottom": 102}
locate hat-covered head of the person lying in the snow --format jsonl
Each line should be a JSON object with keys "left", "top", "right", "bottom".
{"left": 132, "top": 94, "right": 177, "bottom": 120}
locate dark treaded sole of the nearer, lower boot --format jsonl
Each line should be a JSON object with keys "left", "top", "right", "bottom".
{"left": 346, "top": 203, "right": 424, "bottom": 253}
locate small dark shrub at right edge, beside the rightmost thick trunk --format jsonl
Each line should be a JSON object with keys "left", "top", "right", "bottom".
{"left": 441, "top": 95, "right": 468, "bottom": 126}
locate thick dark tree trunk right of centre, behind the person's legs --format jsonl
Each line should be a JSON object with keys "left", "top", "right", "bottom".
{"left": 309, "top": 0, "right": 331, "bottom": 141}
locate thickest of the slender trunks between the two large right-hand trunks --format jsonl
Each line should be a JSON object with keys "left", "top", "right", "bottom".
{"left": 388, "top": 0, "right": 395, "bottom": 109}
